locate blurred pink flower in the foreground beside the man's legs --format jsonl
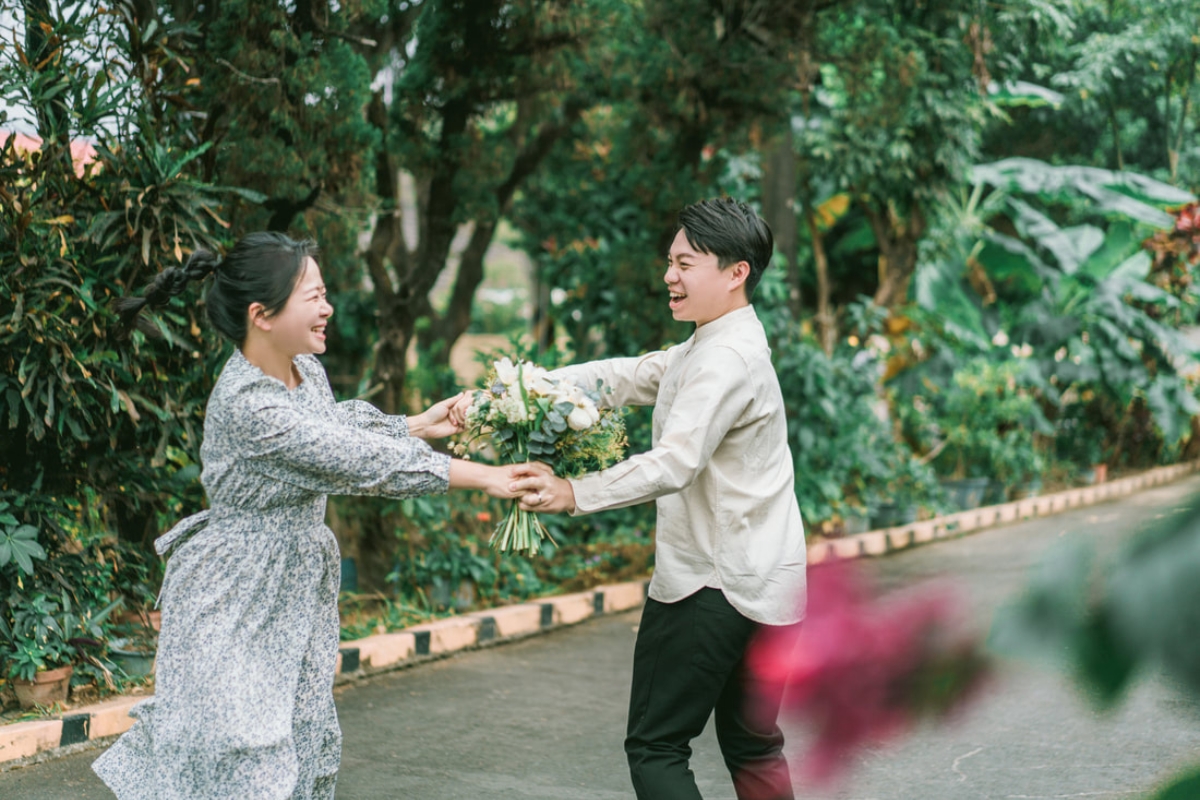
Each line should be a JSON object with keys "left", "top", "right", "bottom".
{"left": 748, "top": 564, "right": 986, "bottom": 783}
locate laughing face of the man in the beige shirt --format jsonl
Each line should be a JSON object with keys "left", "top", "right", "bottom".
{"left": 662, "top": 228, "right": 750, "bottom": 326}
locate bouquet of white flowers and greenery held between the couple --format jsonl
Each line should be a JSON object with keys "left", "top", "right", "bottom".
{"left": 454, "top": 357, "right": 626, "bottom": 555}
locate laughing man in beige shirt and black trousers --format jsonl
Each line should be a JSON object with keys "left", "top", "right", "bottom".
{"left": 511, "top": 198, "right": 805, "bottom": 800}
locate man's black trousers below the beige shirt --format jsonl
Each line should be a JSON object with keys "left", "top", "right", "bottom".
{"left": 625, "top": 589, "right": 794, "bottom": 800}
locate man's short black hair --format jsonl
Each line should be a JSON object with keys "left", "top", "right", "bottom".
{"left": 676, "top": 197, "right": 775, "bottom": 300}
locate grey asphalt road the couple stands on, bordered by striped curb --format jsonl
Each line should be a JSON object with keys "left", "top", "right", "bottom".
{"left": 0, "top": 477, "right": 1200, "bottom": 800}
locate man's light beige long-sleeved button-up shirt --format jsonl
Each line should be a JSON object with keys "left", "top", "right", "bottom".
{"left": 554, "top": 306, "right": 806, "bottom": 625}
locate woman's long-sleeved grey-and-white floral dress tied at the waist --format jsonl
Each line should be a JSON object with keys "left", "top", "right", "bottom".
{"left": 92, "top": 350, "right": 450, "bottom": 800}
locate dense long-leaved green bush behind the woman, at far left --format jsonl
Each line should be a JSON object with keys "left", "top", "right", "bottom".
{"left": 0, "top": 4, "right": 228, "bottom": 685}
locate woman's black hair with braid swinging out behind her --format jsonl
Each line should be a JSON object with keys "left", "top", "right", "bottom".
{"left": 116, "top": 231, "right": 317, "bottom": 344}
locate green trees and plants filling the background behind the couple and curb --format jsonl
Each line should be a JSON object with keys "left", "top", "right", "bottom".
{"left": 0, "top": 0, "right": 1200, "bottom": 734}
